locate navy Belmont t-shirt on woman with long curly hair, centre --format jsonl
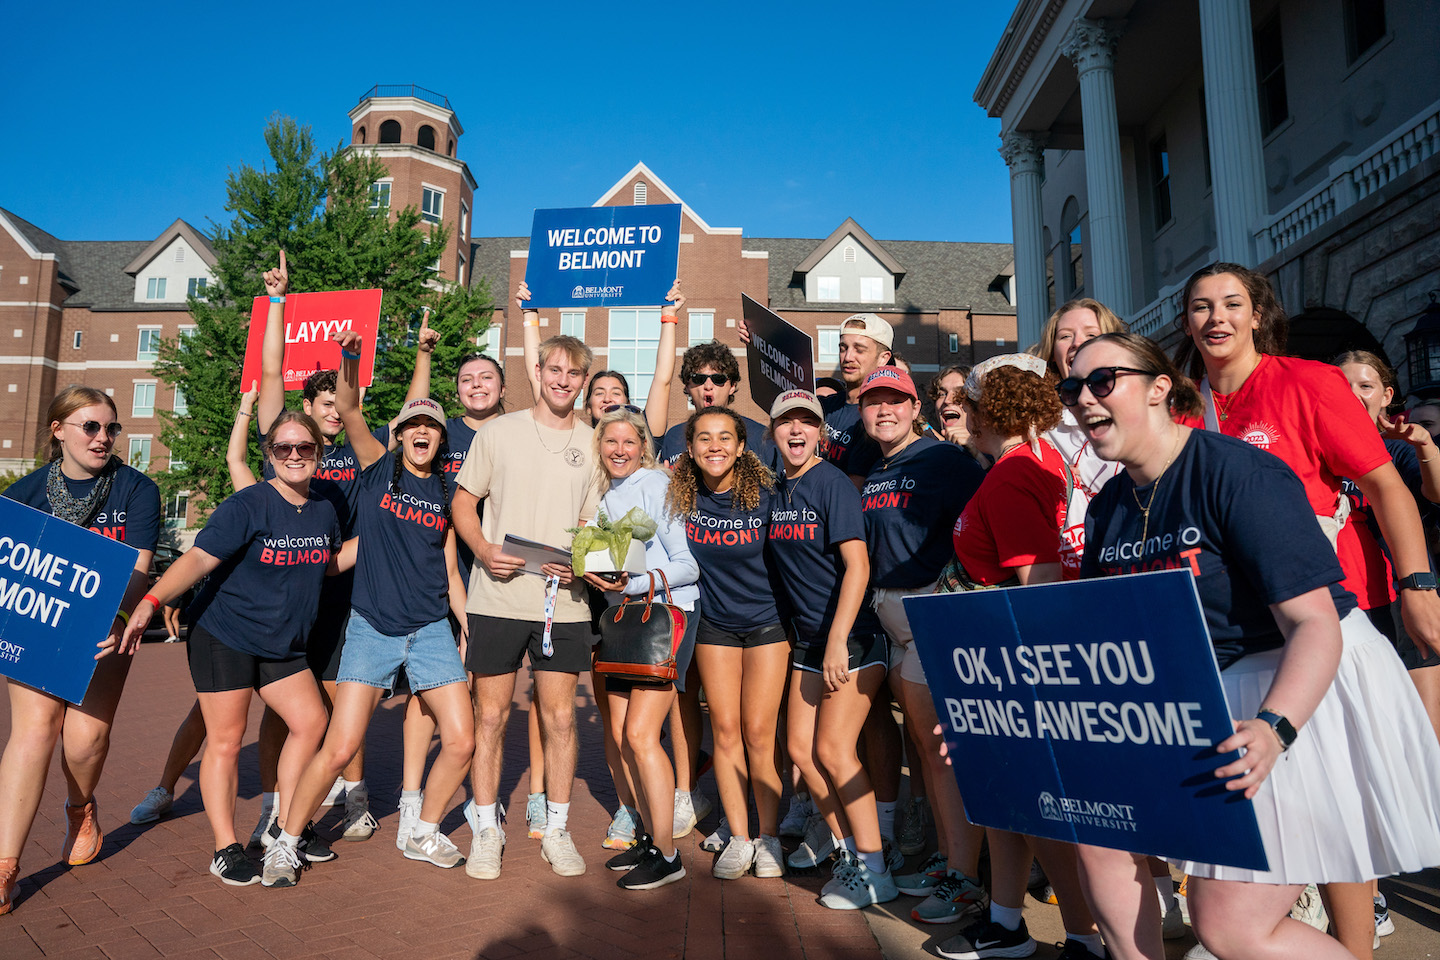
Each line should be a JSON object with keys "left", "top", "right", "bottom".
{"left": 685, "top": 482, "right": 780, "bottom": 633}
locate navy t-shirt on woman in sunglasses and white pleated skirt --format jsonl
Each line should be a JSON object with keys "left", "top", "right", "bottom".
{"left": 1080, "top": 430, "right": 1355, "bottom": 669}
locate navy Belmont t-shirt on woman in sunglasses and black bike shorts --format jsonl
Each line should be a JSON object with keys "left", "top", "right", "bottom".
{"left": 189, "top": 482, "right": 341, "bottom": 659}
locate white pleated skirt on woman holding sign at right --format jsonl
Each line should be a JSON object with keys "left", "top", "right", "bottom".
{"left": 1176, "top": 610, "right": 1440, "bottom": 884}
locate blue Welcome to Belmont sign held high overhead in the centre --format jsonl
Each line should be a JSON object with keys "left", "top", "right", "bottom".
{"left": 526, "top": 203, "right": 680, "bottom": 308}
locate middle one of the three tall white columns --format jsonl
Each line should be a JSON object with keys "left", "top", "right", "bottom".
{"left": 1060, "top": 19, "right": 1130, "bottom": 317}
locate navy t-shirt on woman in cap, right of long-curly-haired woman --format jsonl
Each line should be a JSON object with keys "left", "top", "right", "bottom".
{"left": 770, "top": 462, "right": 880, "bottom": 642}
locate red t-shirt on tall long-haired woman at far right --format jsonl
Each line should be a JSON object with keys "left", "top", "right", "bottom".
{"left": 1212, "top": 354, "right": 1394, "bottom": 610}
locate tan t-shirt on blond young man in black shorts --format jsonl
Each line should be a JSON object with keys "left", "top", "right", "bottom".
{"left": 456, "top": 410, "right": 600, "bottom": 623}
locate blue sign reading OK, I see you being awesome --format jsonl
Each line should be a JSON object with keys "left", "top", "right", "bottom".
{"left": 904, "top": 570, "right": 1269, "bottom": 871}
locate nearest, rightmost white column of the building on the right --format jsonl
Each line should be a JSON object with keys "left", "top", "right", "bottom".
{"left": 1200, "top": 0, "right": 1270, "bottom": 266}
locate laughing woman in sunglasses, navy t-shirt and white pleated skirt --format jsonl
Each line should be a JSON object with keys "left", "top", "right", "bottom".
{"left": 1060, "top": 331, "right": 1440, "bottom": 960}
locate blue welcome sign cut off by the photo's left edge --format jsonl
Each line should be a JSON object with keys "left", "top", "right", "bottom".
{"left": 0, "top": 497, "right": 140, "bottom": 704}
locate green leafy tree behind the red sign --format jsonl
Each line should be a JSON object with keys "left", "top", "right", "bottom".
{"left": 154, "top": 118, "right": 491, "bottom": 521}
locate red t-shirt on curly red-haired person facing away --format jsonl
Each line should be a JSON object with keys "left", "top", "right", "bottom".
{"left": 955, "top": 440, "right": 1080, "bottom": 586}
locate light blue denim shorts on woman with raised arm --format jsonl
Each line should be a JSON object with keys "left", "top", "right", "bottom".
{"left": 336, "top": 610, "right": 465, "bottom": 692}
